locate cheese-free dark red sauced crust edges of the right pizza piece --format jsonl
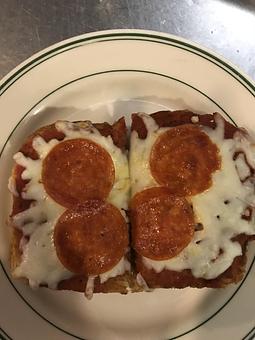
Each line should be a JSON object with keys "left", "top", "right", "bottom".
{"left": 131, "top": 110, "right": 254, "bottom": 288}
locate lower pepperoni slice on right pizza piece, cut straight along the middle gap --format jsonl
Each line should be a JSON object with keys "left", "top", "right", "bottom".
{"left": 131, "top": 187, "right": 195, "bottom": 260}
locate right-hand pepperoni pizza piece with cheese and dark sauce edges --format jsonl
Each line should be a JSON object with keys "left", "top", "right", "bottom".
{"left": 129, "top": 111, "right": 255, "bottom": 288}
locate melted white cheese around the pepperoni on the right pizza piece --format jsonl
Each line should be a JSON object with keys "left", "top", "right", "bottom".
{"left": 131, "top": 115, "right": 255, "bottom": 279}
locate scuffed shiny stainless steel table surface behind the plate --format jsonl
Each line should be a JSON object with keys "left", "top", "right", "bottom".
{"left": 0, "top": 0, "right": 255, "bottom": 79}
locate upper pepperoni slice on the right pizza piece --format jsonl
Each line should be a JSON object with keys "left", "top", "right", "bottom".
{"left": 150, "top": 124, "right": 220, "bottom": 196}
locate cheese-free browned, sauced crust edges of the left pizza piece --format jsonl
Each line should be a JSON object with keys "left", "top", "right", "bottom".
{"left": 10, "top": 118, "right": 141, "bottom": 294}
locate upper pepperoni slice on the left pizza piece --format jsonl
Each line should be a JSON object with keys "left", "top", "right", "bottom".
{"left": 42, "top": 138, "right": 115, "bottom": 208}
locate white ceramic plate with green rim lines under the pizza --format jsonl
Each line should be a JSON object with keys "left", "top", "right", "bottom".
{"left": 0, "top": 30, "right": 255, "bottom": 340}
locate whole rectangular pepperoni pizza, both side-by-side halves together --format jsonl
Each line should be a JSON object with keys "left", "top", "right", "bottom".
{"left": 9, "top": 111, "right": 255, "bottom": 298}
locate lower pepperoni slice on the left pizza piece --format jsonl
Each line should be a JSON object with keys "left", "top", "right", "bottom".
{"left": 54, "top": 200, "right": 128, "bottom": 275}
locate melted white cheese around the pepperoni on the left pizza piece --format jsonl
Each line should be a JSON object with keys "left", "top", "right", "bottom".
{"left": 10, "top": 121, "right": 130, "bottom": 288}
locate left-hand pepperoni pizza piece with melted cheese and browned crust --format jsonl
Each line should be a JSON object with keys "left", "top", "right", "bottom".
{"left": 9, "top": 118, "right": 141, "bottom": 298}
